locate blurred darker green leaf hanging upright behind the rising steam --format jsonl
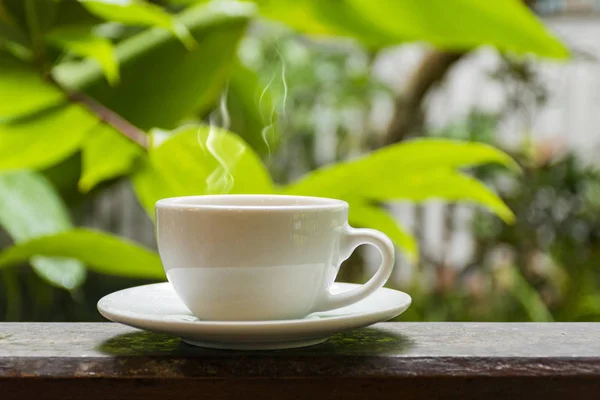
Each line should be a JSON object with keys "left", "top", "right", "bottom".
{"left": 227, "top": 63, "right": 277, "bottom": 155}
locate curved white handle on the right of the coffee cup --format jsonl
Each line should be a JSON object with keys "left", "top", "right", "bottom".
{"left": 314, "top": 226, "right": 394, "bottom": 311}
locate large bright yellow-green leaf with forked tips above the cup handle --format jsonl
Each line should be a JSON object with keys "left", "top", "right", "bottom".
{"left": 283, "top": 139, "right": 518, "bottom": 222}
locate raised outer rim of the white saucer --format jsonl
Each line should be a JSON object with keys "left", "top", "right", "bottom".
{"left": 96, "top": 282, "right": 412, "bottom": 333}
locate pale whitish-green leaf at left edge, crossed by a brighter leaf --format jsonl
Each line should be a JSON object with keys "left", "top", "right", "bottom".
{"left": 0, "top": 171, "right": 85, "bottom": 290}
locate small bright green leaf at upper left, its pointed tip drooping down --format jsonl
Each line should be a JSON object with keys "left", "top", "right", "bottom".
{"left": 46, "top": 26, "right": 119, "bottom": 85}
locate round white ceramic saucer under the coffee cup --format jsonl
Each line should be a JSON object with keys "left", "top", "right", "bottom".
{"left": 98, "top": 282, "right": 411, "bottom": 350}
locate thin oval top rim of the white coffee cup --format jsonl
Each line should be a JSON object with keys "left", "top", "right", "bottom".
{"left": 156, "top": 194, "right": 348, "bottom": 212}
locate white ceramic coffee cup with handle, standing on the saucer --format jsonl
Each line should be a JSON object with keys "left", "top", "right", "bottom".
{"left": 156, "top": 195, "right": 394, "bottom": 320}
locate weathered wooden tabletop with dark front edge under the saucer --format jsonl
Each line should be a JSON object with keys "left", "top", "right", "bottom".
{"left": 0, "top": 323, "right": 600, "bottom": 400}
